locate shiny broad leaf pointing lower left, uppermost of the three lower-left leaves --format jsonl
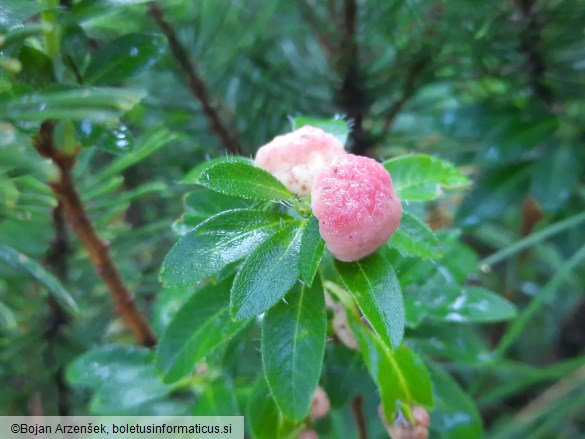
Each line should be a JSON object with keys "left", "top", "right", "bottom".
{"left": 160, "top": 209, "right": 291, "bottom": 286}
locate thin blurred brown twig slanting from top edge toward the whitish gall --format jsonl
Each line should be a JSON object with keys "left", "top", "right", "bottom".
{"left": 149, "top": 2, "right": 242, "bottom": 154}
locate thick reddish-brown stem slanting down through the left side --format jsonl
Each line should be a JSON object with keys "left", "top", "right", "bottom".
{"left": 33, "top": 122, "right": 156, "bottom": 347}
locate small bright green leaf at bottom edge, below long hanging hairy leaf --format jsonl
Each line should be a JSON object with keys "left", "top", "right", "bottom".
{"left": 247, "top": 376, "right": 280, "bottom": 439}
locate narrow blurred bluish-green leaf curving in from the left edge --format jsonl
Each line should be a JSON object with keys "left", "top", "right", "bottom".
{"left": 0, "top": 244, "right": 79, "bottom": 314}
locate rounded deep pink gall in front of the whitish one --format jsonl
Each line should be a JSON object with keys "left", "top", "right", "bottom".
{"left": 311, "top": 154, "right": 402, "bottom": 262}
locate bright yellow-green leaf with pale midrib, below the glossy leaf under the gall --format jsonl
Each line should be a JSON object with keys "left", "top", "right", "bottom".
{"left": 348, "top": 310, "right": 433, "bottom": 419}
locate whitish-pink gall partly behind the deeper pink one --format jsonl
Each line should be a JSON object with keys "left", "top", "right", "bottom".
{"left": 254, "top": 125, "right": 345, "bottom": 195}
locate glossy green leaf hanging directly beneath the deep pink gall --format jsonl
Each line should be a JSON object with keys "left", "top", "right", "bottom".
{"left": 335, "top": 252, "right": 405, "bottom": 349}
